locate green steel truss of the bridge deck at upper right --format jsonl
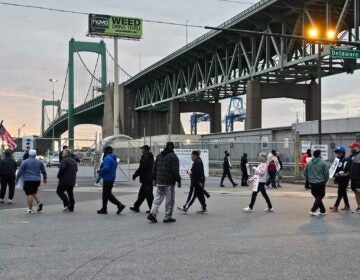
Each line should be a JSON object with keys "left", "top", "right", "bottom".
{"left": 132, "top": 0, "right": 360, "bottom": 110}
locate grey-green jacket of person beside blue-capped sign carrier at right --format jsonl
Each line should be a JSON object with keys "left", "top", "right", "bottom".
{"left": 304, "top": 158, "right": 329, "bottom": 184}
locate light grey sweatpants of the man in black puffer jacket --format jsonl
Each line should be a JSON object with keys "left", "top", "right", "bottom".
{"left": 150, "top": 186, "right": 175, "bottom": 219}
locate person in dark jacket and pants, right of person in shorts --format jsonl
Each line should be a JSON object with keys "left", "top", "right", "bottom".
{"left": 56, "top": 149, "right": 78, "bottom": 212}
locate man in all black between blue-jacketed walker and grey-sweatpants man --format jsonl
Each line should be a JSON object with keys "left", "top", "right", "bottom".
{"left": 130, "top": 145, "right": 154, "bottom": 214}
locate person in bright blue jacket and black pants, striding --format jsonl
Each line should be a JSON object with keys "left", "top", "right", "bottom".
{"left": 97, "top": 146, "right": 125, "bottom": 215}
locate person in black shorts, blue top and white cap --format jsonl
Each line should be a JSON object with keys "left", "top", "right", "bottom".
{"left": 16, "top": 149, "right": 47, "bottom": 214}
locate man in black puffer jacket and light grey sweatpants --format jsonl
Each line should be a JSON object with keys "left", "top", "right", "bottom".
{"left": 147, "top": 142, "right": 181, "bottom": 223}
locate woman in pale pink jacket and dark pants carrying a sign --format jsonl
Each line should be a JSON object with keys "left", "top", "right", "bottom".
{"left": 244, "top": 154, "right": 274, "bottom": 212}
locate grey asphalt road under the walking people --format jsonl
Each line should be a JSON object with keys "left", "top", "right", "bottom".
{"left": 0, "top": 170, "right": 360, "bottom": 280}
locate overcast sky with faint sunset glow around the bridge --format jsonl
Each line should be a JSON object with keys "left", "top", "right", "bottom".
{"left": 0, "top": 0, "right": 360, "bottom": 140}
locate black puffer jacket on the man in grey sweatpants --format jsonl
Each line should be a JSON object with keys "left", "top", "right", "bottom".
{"left": 153, "top": 148, "right": 181, "bottom": 186}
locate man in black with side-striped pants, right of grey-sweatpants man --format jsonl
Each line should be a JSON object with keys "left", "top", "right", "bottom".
{"left": 178, "top": 151, "right": 209, "bottom": 214}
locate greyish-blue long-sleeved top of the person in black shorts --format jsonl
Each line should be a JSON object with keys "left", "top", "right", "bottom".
{"left": 16, "top": 157, "right": 47, "bottom": 182}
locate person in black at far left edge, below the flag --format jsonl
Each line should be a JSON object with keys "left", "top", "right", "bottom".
{"left": 0, "top": 149, "right": 17, "bottom": 204}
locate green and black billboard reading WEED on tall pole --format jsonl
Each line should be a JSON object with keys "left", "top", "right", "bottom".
{"left": 89, "top": 14, "right": 142, "bottom": 39}
